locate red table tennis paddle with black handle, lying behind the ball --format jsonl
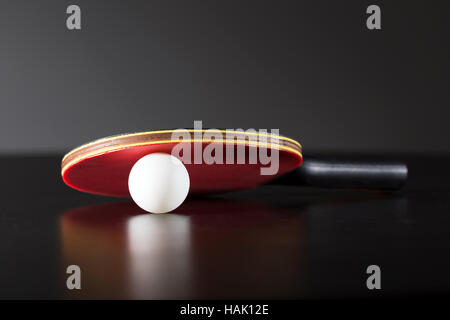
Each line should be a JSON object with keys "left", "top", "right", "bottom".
{"left": 61, "top": 129, "right": 407, "bottom": 197}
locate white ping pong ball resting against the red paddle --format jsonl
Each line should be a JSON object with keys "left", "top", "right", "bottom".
{"left": 128, "top": 153, "right": 190, "bottom": 213}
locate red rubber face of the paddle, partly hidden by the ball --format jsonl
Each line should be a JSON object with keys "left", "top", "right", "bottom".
{"left": 62, "top": 143, "right": 302, "bottom": 197}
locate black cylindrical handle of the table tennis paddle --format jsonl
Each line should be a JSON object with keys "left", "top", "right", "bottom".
{"left": 276, "top": 157, "right": 408, "bottom": 190}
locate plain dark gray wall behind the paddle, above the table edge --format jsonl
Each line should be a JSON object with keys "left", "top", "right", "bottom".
{"left": 0, "top": 0, "right": 450, "bottom": 153}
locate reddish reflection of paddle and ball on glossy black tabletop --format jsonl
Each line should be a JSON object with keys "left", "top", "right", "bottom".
{"left": 61, "top": 199, "right": 304, "bottom": 299}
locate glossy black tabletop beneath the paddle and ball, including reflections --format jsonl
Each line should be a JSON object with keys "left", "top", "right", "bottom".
{"left": 0, "top": 155, "right": 450, "bottom": 299}
